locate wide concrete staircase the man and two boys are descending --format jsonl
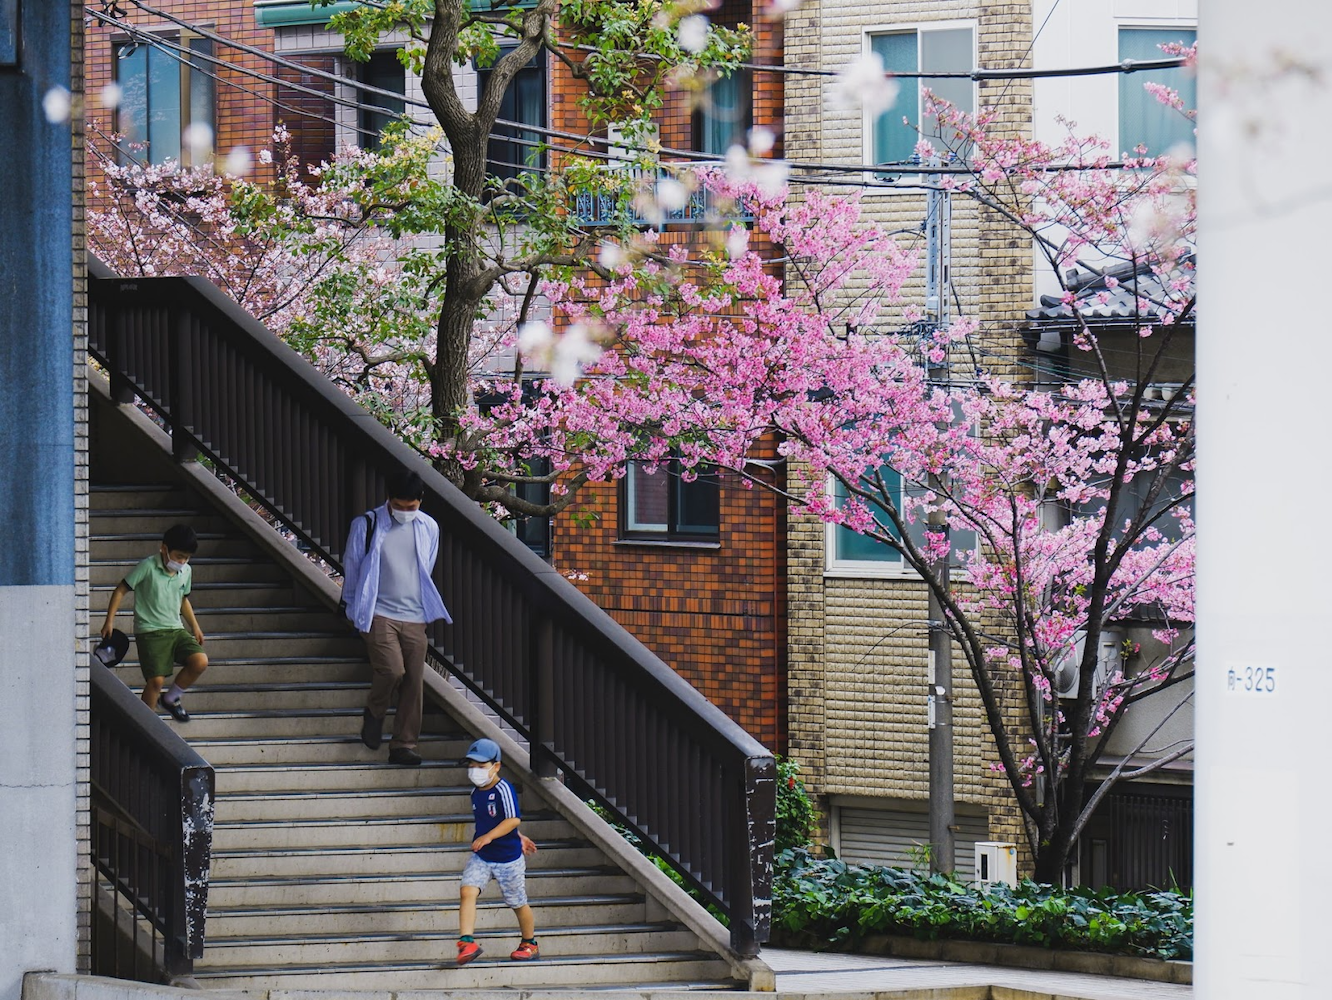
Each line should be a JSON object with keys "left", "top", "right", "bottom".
{"left": 89, "top": 482, "right": 746, "bottom": 989}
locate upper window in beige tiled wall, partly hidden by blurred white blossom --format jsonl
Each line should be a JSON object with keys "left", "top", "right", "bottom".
{"left": 868, "top": 24, "right": 976, "bottom": 164}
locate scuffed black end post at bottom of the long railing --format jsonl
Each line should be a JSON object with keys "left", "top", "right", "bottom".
{"left": 729, "top": 756, "right": 777, "bottom": 957}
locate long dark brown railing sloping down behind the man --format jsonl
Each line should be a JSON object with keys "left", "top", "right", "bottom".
{"left": 89, "top": 258, "right": 777, "bottom": 955}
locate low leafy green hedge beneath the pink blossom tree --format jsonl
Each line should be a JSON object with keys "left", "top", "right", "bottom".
{"left": 773, "top": 850, "right": 1193, "bottom": 959}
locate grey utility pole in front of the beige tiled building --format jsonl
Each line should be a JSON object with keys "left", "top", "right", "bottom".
{"left": 924, "top": 175, "right": 956, "bottom": 872}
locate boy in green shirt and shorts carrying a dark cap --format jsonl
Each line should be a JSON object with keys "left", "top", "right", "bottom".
{"left": 101, "top": 525, "right": 208, "bottom": 722}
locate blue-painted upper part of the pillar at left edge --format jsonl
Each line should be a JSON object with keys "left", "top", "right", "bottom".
{"left": 0, "top": 0, "right": 75, "bottom": 586}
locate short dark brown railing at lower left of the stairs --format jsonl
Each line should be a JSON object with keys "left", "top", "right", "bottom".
{"left": 89, "top": 662, "right": 213, "bottom": 983}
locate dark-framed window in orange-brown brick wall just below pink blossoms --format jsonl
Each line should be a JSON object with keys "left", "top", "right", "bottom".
{"left": 619, "top": 462, "right": 722, "bottom": 542}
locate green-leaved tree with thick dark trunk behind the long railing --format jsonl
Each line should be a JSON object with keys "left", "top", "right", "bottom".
{"left": 312, "top": 0, "right": 749, "bottom": 514}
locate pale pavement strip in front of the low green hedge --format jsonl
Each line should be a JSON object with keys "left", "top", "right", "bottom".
{"left": 762, "top": 948, "right": 1193, "bottom": 1000}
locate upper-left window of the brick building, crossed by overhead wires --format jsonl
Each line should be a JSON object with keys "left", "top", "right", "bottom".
{"left": 112, "top": 35, "right": 217, "bottom": 166}
